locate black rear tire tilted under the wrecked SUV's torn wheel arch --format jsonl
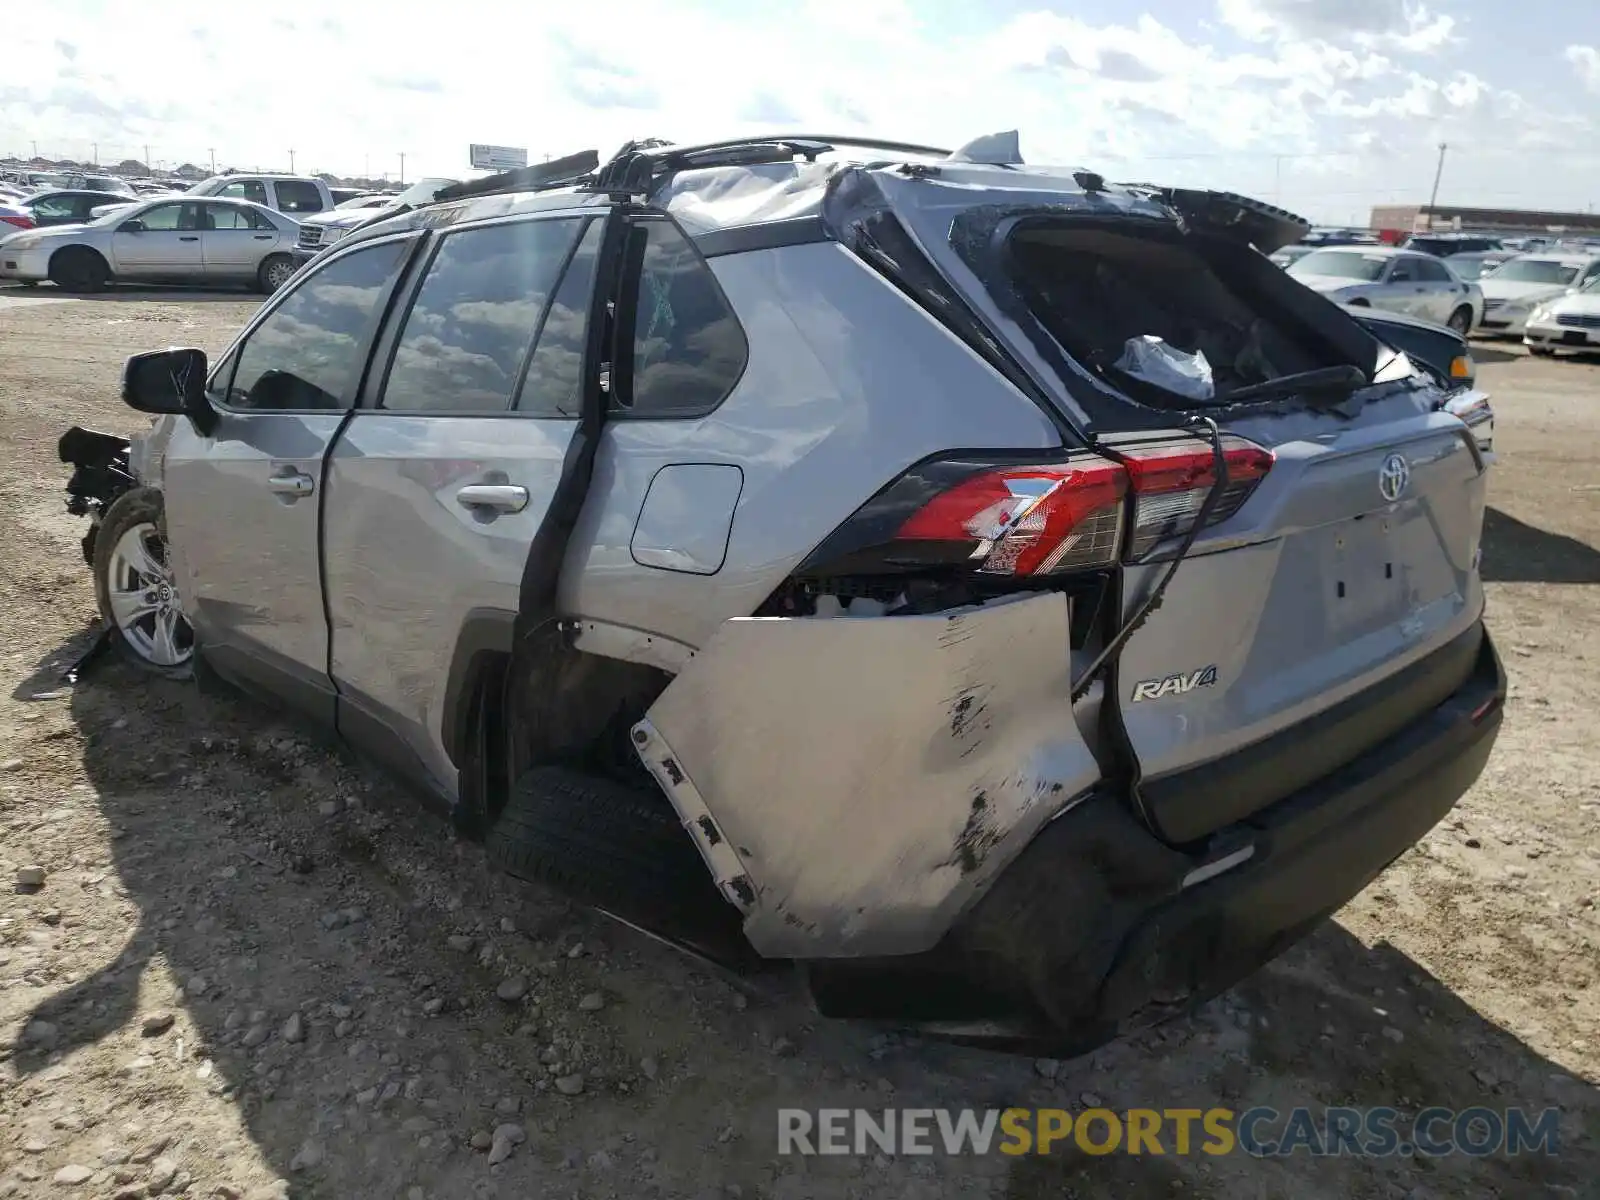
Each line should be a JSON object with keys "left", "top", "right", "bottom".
{"left": 485, "top": 766, "right": 742, "bottom": 942}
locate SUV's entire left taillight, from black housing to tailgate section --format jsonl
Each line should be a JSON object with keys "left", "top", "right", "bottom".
{"left": 800, "top": 437, "right": 1272, "bottom": 579}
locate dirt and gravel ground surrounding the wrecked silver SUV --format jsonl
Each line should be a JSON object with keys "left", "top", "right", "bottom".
{"left": 0, "top": 290, "right": 1600, "bottom": 1200}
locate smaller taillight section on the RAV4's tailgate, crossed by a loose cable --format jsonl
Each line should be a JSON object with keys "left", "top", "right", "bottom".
{"left": 1118, "top": 435, "right": 1272, "bottom": 562}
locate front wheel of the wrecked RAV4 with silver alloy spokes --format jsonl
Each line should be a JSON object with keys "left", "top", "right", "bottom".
{"left": 94, "top": 488, "right": 195, "bottom": 678}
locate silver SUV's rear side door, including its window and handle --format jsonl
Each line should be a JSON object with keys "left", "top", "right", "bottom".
{"left": 323, "top": 208, "right": 606, "bottom": 797}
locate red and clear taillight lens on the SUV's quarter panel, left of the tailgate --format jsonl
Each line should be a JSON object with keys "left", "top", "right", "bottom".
{"left": 896, "top": 454, "right": 1128, "bottom": 576}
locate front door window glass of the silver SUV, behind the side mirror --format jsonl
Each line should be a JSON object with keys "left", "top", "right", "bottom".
{"left": 227, "top": 242, "right": 408, "bottom": 411}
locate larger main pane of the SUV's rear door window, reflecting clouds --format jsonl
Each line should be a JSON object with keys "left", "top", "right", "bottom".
{"left": 379, "top": 219, "right": 579, "bottom": 413}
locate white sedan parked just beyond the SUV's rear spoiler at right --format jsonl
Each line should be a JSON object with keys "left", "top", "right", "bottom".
{"left": 1286, "top": 246, "right": 1483, "bottom": 336}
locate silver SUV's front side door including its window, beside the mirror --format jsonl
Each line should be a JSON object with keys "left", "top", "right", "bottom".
{"left": 163, "top": 238, "right": 411, "bottom": 722}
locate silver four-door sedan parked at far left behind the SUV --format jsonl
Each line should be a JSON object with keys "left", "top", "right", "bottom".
{"left": 0, "top": 197, "right": 299, "bottom": 291}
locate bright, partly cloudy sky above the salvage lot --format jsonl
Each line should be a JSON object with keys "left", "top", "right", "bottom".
{"left": 0, "top": 0, "right": 1600, "bottom": 222}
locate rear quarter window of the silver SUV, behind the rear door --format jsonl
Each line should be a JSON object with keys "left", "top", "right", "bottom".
{"left": 618, "top": 221, "right": 749, "bottom": 416}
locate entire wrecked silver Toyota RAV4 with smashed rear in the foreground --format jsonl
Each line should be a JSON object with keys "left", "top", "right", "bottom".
{"left": 61, "top": 136, "right": 1506, "bottom": 1053}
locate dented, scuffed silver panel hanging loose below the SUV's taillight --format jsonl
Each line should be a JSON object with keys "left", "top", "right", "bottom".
{"left": 635, "top": 594, "right": 1099, "bottom": 958}
